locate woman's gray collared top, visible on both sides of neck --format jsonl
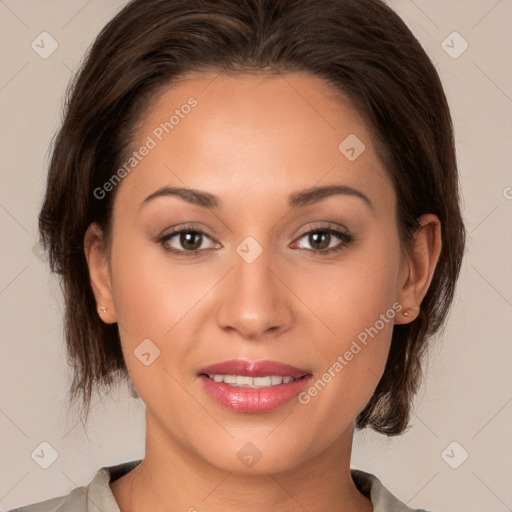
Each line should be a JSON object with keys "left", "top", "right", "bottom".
{"left": 8, "top": 459, "right": 427, "bottom": 512}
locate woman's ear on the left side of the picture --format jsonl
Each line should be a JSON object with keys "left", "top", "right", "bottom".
{"left": 84, "top": 222, "right": 117, "bottom": 324}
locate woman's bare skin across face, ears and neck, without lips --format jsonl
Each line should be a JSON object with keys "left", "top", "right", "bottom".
{"left": 85, "top": 72, "right": 441, "bottom": 512}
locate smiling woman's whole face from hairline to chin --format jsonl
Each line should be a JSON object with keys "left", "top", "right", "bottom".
{"left": 91, "top": 73, "right": 407, "bottom": 473}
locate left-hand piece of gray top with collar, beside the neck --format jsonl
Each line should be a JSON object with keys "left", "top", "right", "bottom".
{"left": 7, "top": 459, "right": 142, "bottom": 512}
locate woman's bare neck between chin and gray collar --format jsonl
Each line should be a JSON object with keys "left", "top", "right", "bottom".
{"left": 111, "top": 417, "right": 372, "bottom": 512}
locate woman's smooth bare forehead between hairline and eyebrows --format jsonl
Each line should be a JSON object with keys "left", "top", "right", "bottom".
{"left": 119, "top": 72, "right": 389, "bottom": 210}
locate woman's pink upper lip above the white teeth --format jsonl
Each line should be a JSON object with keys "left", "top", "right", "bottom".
{"left": 199, "top": 359, "right": 309, "bottom": 379}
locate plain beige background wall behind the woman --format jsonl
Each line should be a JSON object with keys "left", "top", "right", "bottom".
{"left": 0, "top": 0, "right": 512, "bottom": 512}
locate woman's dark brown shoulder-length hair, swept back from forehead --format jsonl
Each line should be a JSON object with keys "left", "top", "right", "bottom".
{"left": 39, "top": 0, "right": 465, "bottom": 435}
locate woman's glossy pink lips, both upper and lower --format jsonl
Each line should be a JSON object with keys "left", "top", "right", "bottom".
{"left": 199, "top": 360, "right": 312, "bottom": 413}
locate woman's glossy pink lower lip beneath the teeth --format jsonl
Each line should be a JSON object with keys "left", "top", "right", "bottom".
{"left": 199, "top": 375, "right": 311, "bottom": 413}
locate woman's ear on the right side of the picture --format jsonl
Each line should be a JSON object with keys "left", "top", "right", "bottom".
{"left": 395, "top": 213, "right": 442, "bottom": 324}
